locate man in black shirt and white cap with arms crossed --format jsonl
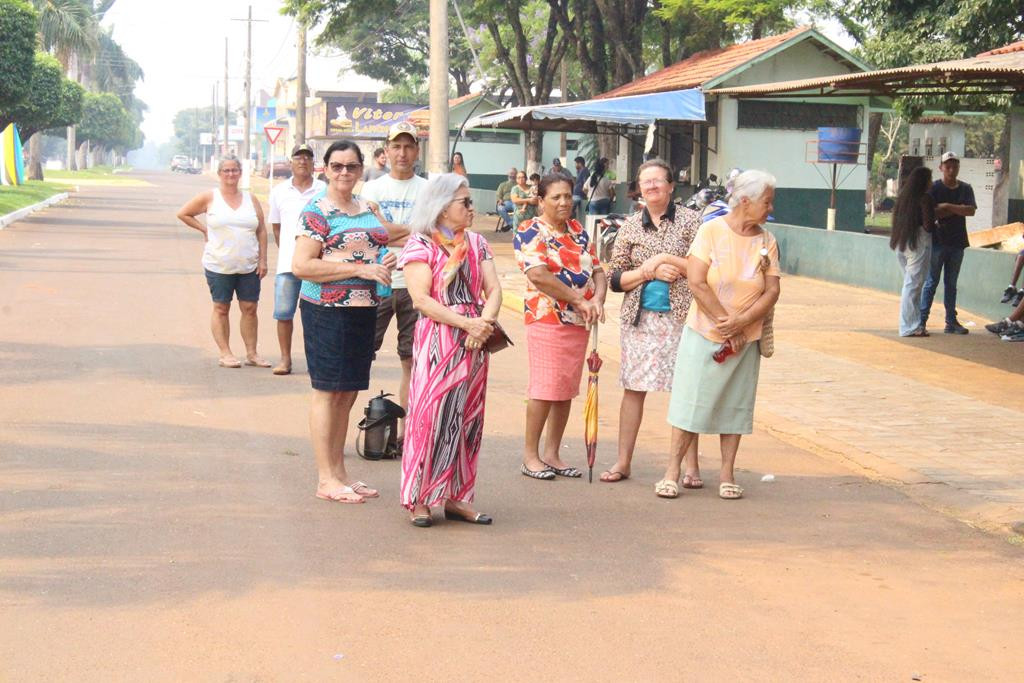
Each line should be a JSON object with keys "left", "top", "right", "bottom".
{"left": 921, "top": 152, "right": 978, "bottom": 335}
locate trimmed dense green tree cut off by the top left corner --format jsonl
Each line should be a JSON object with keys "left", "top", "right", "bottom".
{"left": 0, "top": 0, "right": 39, "bottom": 117}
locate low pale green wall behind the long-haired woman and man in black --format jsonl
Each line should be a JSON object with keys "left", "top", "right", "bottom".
{"left": 769, "top": 223, "right": 1014, "bottom": 328}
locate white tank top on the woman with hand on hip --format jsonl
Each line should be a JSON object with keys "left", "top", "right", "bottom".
{"left": 203, "top": 189, "right": 259, "bottom": 274}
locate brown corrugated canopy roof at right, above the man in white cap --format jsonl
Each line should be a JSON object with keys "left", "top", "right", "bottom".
{"left": 708, "top": 49, "right": 1024, "bottom": 97}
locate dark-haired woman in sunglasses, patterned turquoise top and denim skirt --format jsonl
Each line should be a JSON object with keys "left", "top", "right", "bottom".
{"left": 292, "top": 140, "right": 395, "bottom": 503}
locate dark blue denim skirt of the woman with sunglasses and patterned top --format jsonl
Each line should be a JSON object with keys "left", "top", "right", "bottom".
{"left": 299, "top": 301, "right": 377, "bottom": 391}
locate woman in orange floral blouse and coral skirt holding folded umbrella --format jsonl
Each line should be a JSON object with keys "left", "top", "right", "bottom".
{"left": 512, "top": 173, "right": 607, "bottom": 480}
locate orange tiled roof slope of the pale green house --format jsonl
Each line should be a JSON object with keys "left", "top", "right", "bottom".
{"left": 598, "top": 27, "right": 811, "bottom": 98}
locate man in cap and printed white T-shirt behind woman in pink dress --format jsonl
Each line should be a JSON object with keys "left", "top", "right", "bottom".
{"left": 359, "top": 121, "right": 427, "bottom": 454}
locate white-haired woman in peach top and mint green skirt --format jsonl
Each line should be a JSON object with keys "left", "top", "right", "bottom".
{"left": 654, "top": 171, "right": 780, "bottom": 500}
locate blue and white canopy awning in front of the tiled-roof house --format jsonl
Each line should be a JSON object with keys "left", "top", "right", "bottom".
{"left": 466, "top": 88, "right": 705, "bottom": 133}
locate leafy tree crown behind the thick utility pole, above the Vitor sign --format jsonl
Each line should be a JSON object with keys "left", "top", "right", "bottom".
{"left": 282, "top": 0, "right": 472, "bottom": 95}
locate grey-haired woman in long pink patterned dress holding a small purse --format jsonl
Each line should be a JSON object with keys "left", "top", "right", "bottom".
{"left": 398, "top": 173, "right": 502, "bottom": 526}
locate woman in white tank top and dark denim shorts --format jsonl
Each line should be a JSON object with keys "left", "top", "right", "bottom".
{"left": 178, "top": 157, "right": 270, "bottom": 368}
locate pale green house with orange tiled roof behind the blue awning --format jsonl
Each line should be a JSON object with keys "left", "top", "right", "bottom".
{"left": 599, "top": 27, "right": 870, "bottom": 230}
